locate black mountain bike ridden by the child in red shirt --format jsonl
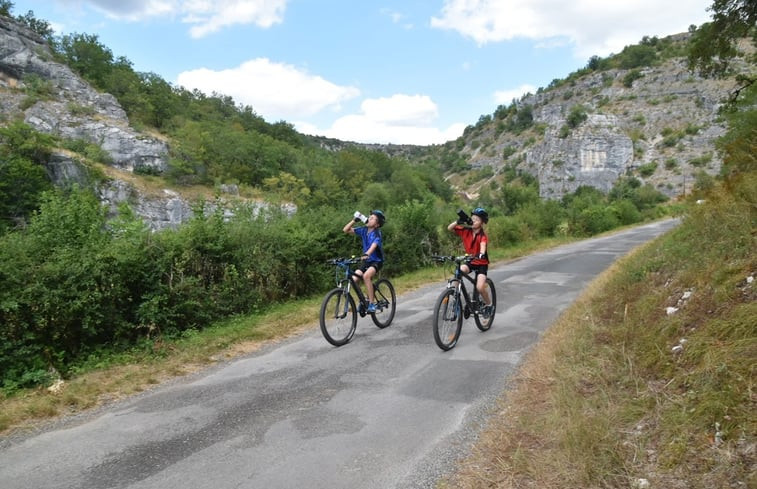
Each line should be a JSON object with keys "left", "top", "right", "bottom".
{"left": 432, "top": 255, "right": 497, "bottom": 351}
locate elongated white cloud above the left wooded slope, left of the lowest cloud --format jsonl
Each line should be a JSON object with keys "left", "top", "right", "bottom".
{"left": 177, "top": 58, "right": 360, "bottom": 122}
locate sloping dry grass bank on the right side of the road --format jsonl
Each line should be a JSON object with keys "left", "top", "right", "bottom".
{"left": 439, "top": 178, "right": 757, "bottom": 489}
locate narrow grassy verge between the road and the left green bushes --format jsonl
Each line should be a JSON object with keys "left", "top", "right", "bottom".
{"left": 0, "top": 239, "right": 564, "bottom": 435}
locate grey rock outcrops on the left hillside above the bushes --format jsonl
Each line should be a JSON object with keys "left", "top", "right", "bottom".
{"left": 0, "top": 17, "right": 207, "bottom": 230}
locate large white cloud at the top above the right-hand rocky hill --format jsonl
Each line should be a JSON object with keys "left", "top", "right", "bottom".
{"left": 431, "top": 0, "right": 711, "bottom": 59}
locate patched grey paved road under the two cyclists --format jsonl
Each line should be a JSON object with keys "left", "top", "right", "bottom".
{"left": 0, "top": 221, "right": 675, "bottom": 489}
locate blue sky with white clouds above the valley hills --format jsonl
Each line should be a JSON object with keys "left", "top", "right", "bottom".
{"left": 11, "top": 0, "right": 713, "bottom": 145}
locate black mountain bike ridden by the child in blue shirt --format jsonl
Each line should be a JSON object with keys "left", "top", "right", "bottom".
{"left": 321, "top": 257, "right": 397, "bottom": 346}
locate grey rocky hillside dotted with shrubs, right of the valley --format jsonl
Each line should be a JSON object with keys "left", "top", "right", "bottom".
{"left": 454, "top": 40, "right": 732, "bottom": 199}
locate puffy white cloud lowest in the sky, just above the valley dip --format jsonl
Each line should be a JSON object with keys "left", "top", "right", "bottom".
{"left": 295, "top": 94, "right": 465, "bottom": 145}
